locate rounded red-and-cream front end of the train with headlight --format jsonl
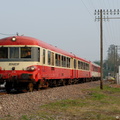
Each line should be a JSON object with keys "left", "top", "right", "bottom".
{"left": 0, "top": 36, "right": 40, "bottom": 92}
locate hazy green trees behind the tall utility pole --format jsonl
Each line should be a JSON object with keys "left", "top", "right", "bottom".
{"left": 94, "top": 44, "right": 120, "bottom": 78}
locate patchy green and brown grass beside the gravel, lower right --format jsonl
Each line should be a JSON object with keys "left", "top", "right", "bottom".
{"left": 2, "top": 86, "right": 120, "bottom": 120}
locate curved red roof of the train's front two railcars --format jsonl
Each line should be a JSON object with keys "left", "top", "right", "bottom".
{"left": 0, "top": 36, "right": 89, "bottom": 62}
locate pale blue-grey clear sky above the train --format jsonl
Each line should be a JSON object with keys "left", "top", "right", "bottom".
{"left": 0, "top": 0, "right": 120, "bottom": 61}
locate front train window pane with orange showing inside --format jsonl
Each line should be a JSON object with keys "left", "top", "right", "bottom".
{"left": 21, "top": 47, "right": 32, "bottom": 58}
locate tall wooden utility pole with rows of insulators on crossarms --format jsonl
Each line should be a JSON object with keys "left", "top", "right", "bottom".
{"left": 95, "top": 9, "right": 120, "bottom": 89}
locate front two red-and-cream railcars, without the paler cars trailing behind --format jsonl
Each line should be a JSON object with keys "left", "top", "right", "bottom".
{"left": 0, "top": 36, "right": 100, "bottom": 92}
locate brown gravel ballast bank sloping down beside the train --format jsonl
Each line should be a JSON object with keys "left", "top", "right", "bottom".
{"left": 0, "top": 81, "right": 99, "bottom": 118}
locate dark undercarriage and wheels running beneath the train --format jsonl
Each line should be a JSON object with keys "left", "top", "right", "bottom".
{"left": 1, "top": 77, "right": 100, "bottom": 93}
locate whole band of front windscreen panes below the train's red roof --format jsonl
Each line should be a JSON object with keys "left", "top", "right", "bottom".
{"left": 0, "top": 47, "right": 40, "bottom": 61}
